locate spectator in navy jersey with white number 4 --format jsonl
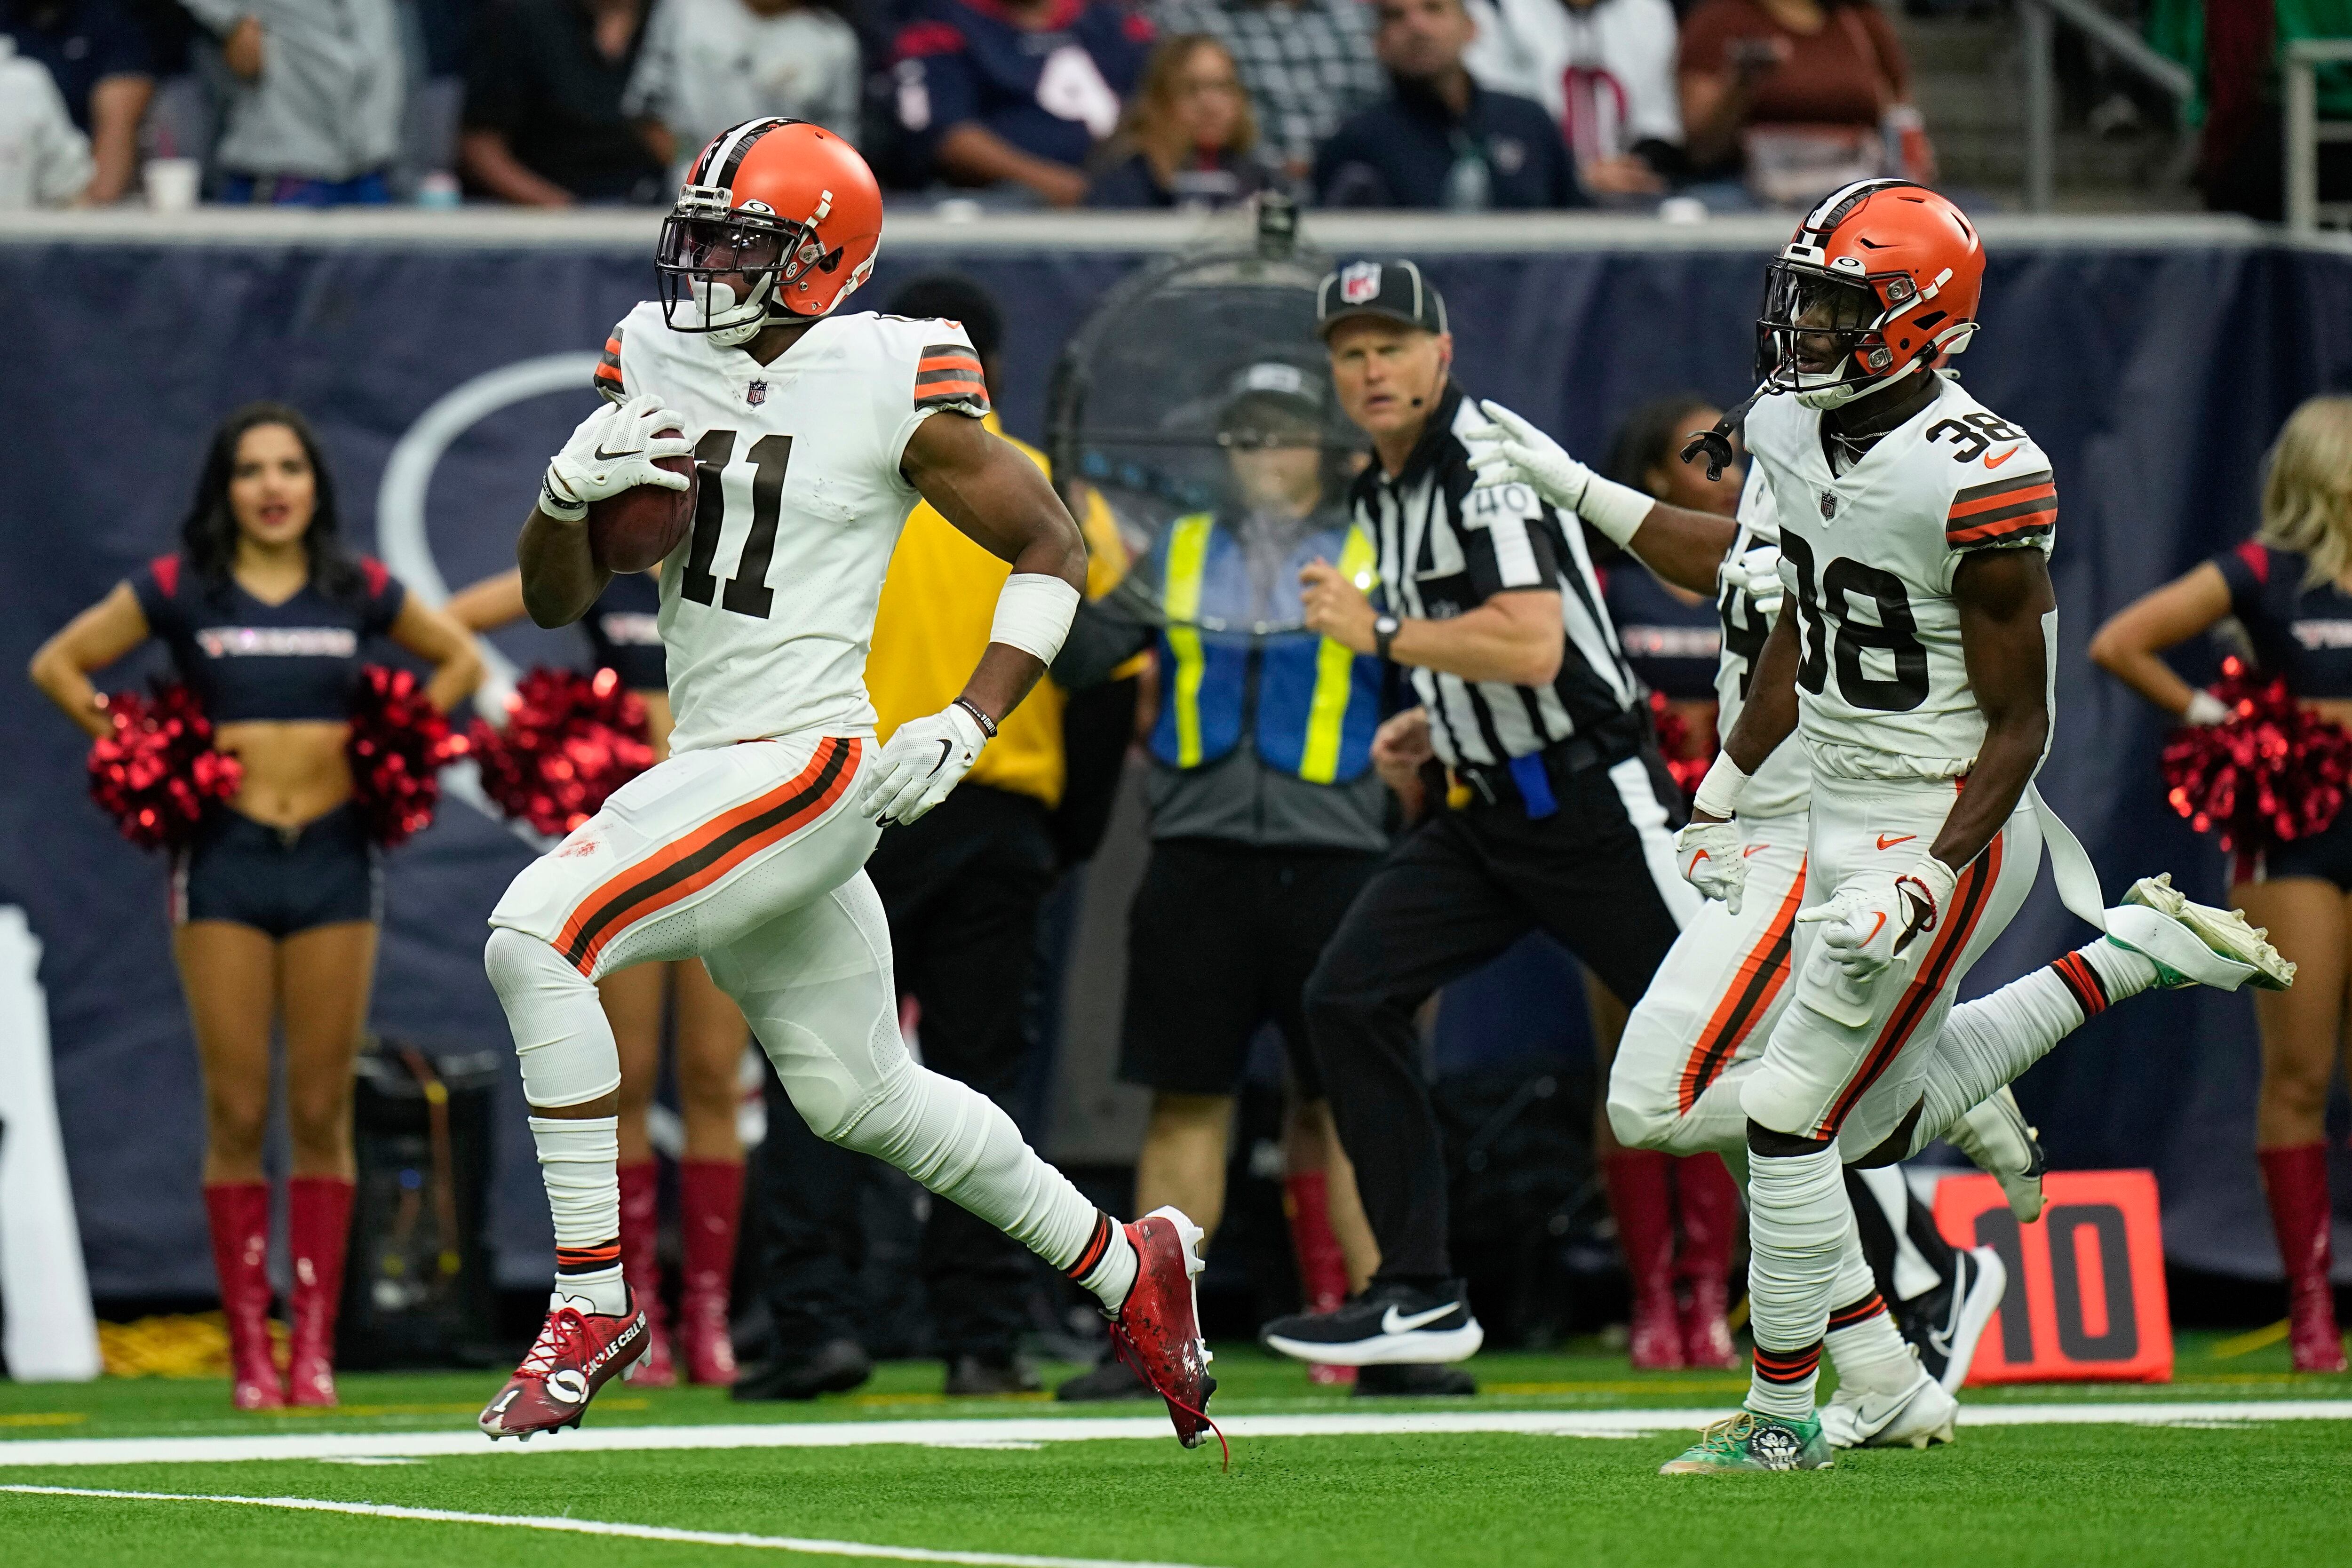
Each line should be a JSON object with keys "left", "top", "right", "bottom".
{"left": 896, "top": 0, "right": 1152, "bottom": 207}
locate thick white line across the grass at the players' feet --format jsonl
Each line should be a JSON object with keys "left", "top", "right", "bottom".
{"left": 0, "top": 1399, "right": 2352, "bottom": 1469}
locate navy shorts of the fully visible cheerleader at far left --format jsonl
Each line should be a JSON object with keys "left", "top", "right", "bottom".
{"left": 172, "top": 802, "right": 383, "bottom": 938}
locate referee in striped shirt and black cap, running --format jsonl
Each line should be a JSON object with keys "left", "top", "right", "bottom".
{"left": 1261, "top": 261, "right": 1698, "bottom": 1366}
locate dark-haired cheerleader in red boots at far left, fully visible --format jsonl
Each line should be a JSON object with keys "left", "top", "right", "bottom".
{"left": 33, "top": 402, "right": 482, "bottom": 1410}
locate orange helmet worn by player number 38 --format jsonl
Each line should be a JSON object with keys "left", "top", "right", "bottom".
{"left": 1757, "top": 179, "right": 1985, "bottom": 409}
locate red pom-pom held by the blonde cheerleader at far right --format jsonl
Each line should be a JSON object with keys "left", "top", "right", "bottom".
{"left": 2164, "top": 658, "right": 2352, "bottom": 851}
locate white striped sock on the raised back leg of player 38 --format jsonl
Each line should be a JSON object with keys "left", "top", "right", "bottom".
{"left": 1910, "top": 938, "right": 2157, "bottom": 1154}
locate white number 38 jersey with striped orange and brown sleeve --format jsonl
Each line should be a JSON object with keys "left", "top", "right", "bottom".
{"left": 1748, "top": 369, "right": 2058, "bottom": 778}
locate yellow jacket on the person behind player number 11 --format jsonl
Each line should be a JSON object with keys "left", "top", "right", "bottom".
{"left": 866, "top": 414, "right": 1127, "bottom": 806}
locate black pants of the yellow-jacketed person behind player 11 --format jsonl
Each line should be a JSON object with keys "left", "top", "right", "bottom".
{"left": 753, "top": 785, "right": 1054, "bottom": 1359}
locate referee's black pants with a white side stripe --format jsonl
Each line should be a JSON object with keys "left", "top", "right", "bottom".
{"left": 1305, "top": 755, "right": 1679, "bottom": 1288}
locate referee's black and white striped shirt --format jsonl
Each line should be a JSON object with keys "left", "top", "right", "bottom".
{"left": 1350, "top": 383, "right": 1642, "bottom": 764}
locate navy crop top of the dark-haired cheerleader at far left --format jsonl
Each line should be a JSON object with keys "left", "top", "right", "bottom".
{"left": 132, "top": 555, "right": 407, "bottom": 724}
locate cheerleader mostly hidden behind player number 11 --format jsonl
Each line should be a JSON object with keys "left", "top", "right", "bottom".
{"left": 449, "top": 571, "right": 750, "bottom": 1387}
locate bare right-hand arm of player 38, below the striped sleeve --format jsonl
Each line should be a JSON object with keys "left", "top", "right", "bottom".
{"left": 1929, "top": 548, "right": 2058, "bottom": 872}
